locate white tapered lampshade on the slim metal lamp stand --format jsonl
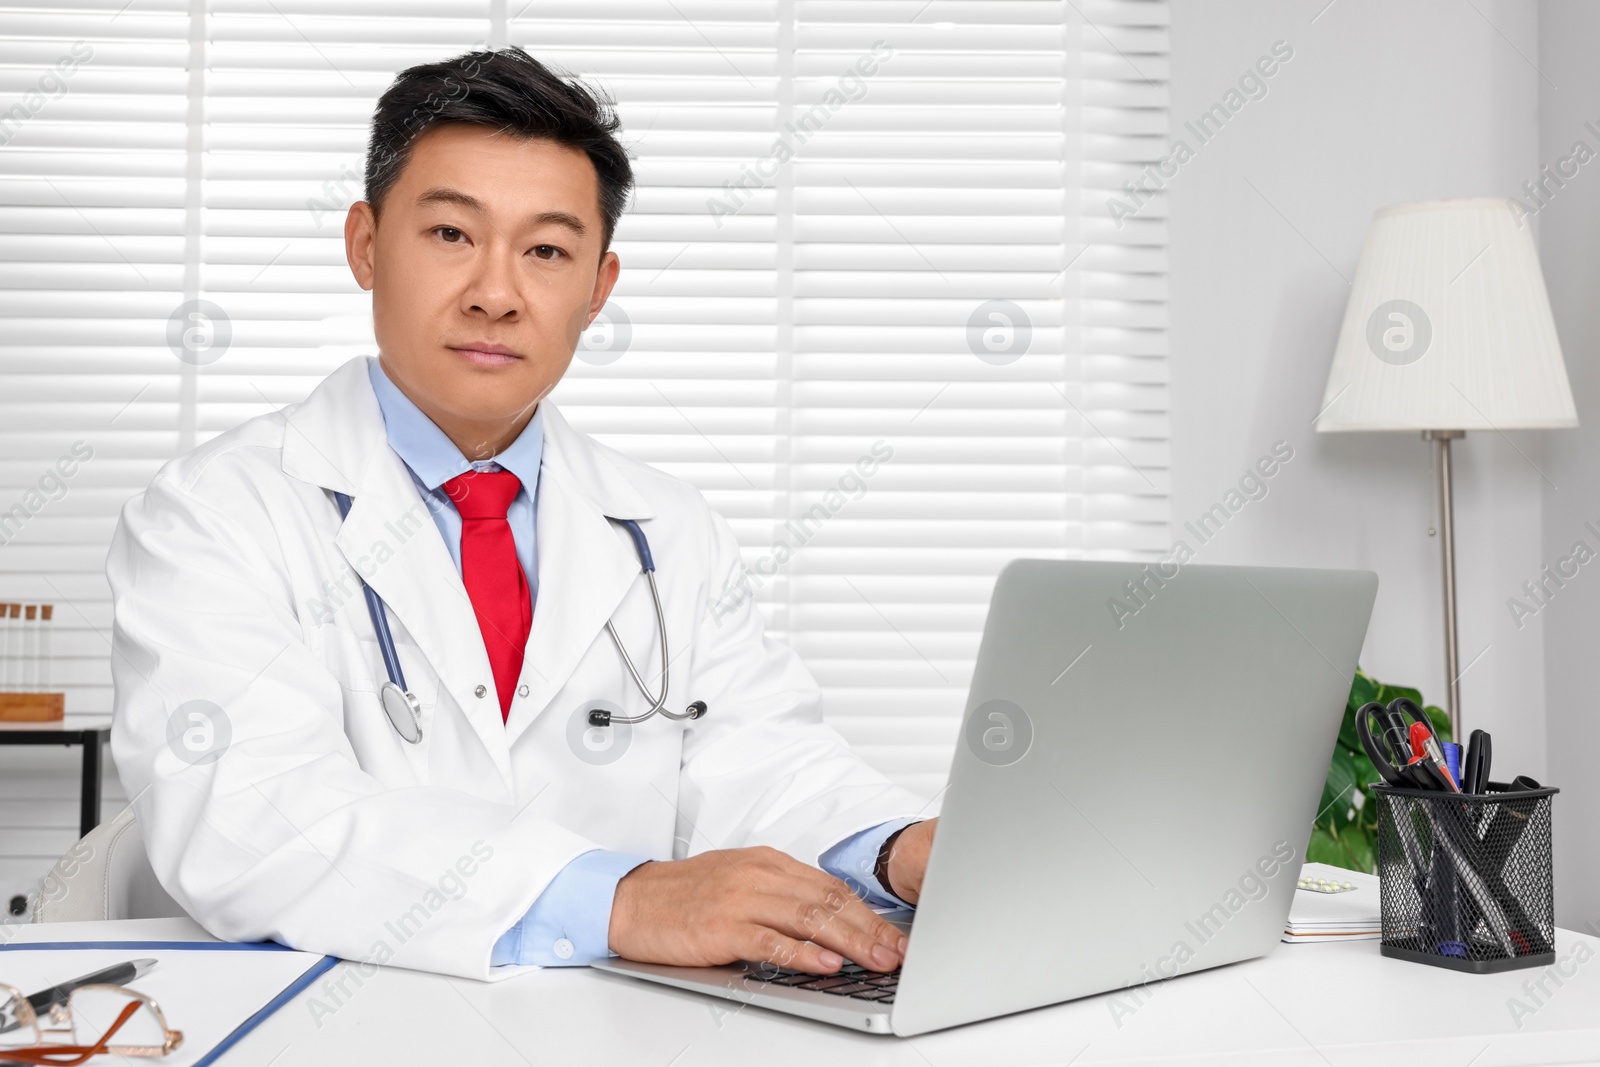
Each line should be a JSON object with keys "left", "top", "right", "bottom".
{"left": 1317, "top": 197, "right": 1578, "bottom": 432}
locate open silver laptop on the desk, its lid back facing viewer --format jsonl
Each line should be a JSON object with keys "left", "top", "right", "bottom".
{"left": 595, "top": 560, "right": 1378, "bottom": 1035}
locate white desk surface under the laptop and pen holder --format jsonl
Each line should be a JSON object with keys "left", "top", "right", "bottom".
{"left": 3, "top": 920, "right": 1600, "bottom": 1067}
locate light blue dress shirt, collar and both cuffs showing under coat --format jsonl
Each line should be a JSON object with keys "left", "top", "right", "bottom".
{"left": 368, "top": 358, "right": 915, "bottom": 966}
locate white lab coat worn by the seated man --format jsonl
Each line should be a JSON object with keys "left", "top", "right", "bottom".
{"left": 107, "top": 358, "right": 930, "bottom": 979}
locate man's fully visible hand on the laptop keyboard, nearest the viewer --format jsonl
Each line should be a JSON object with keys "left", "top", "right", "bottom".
{"left": 610, "top": 851, "right": 908, "bottom": 974}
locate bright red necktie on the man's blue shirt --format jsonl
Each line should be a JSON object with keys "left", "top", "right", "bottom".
{"left": 445, "top": 470, "right": 533, "bottom": 721}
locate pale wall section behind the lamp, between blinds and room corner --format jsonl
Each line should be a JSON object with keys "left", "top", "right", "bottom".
{"left": 1170, "top": 0, "right": 1561, "bottom": 851}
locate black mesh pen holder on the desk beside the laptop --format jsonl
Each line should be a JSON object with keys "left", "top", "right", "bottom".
{"left": 1373, "top": 782, "right": 1560, "bottom": 974}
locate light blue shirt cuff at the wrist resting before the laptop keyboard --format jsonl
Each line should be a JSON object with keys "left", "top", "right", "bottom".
{"left": 490, "top": 849, "right": 650, "bottom": 966}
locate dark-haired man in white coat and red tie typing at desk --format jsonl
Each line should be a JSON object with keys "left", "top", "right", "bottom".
{"left": 107, "top": 50, "right": 934, "bottom": 979}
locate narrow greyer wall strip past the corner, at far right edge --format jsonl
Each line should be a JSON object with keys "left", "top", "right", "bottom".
{"left": 1536, "top": 0, "right": 1600, "bottom": 929}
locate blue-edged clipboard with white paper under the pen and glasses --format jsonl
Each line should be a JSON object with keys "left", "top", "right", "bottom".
{"left": 0, "top": 941, "right": 339, "bottom": 1067}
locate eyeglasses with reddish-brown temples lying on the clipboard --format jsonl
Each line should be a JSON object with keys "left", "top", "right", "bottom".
{"left": 0, "top": 984, "right": 184, "bottom": 1067}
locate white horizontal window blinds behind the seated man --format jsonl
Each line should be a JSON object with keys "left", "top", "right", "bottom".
{"left": 0, "top": 0, "right": 1168, "bottom": 809}
